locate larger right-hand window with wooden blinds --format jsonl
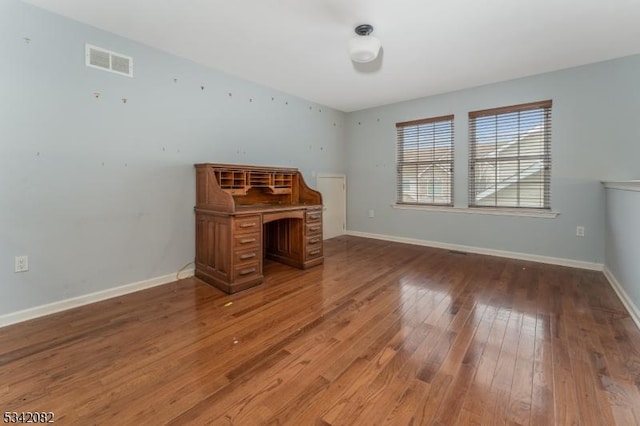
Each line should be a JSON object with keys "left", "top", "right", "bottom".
{"left": 469, "top": 100, "right": 551, "bottom": 210}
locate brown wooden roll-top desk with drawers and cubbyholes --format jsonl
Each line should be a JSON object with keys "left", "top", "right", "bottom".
{"left": 195, "top": 163, "right": 324, "bottom": 293}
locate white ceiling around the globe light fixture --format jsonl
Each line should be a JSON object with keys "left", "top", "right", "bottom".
{"left": 26, "top": 0, "right": 640, "bottom": 112}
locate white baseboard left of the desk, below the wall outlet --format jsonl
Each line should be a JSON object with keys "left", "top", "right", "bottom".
{"left": 0, "top": 268, "right": 194, "bottom": 327}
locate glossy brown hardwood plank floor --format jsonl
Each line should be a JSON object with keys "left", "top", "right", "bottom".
{"left": 0, "top": 236, "right": 640, "bottom": 425}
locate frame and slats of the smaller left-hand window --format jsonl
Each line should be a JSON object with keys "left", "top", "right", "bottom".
{"left": 396, "top": 114, "right": 455, "bottom": 208}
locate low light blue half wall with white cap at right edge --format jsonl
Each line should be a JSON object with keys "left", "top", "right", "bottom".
{"left": 605, "top": 190, "right": 640, "bottom": 312}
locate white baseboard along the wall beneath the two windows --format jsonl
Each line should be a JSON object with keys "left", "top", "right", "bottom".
{"left": 347, "top": 231, "right": 603, "bottom": 271}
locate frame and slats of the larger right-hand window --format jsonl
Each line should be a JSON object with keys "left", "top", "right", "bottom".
{"left": 468, "top": 100, "right": 553, "bottom": 212}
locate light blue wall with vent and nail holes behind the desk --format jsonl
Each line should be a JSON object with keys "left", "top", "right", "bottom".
{"left": 0, "top": 0, "right": 345, "bottom": 315}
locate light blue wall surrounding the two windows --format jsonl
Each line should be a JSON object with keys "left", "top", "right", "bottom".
{"left": 346, "top": 56, "right": 640, "bottom": 263}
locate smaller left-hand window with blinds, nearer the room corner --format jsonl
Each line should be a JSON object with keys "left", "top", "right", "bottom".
{"left": 396, "top": 115, "right": 453, "bottom": 206}
